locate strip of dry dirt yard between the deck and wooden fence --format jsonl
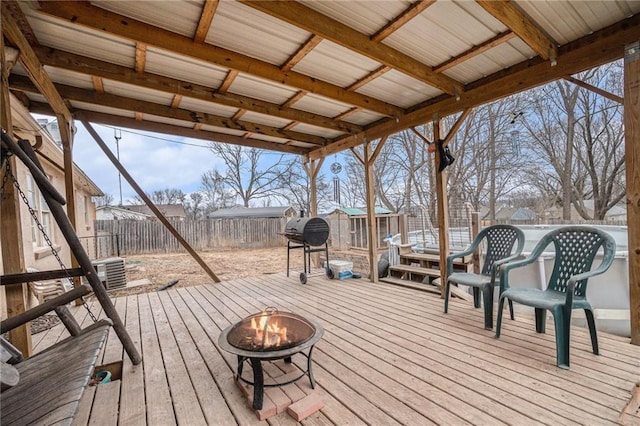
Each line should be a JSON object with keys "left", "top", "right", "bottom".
{"left": 109, "top": 247, "right": 302, "bottom": 297}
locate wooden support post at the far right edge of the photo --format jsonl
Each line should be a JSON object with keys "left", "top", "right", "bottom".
{"left": 624, "top": 41, "right": 640, "bottom": 345}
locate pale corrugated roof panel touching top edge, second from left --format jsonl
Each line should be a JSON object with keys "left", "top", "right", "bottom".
{"left": 206, "top": 1, "right": 310, "bottom": 65}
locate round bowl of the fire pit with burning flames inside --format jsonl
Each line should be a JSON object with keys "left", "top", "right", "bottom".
{"left": 227, "top": 308, "right": 316, "bottom": 352}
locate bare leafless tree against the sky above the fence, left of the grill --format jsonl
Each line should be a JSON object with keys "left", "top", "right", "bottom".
{"left": 210, "top": 143, "right": 283, "bottom": 207}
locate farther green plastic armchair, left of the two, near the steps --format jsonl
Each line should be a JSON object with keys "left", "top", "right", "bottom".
{"left": 444, "top": 225, "right": 524, "bottom": 330}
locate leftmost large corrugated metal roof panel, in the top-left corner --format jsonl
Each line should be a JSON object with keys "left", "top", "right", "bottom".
{"left": 24, "top": 8, "right": 136, "bottom": 68}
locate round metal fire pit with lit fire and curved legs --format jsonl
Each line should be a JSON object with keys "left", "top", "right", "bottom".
{"left": 218, "top": 308, "right": 324, "bottom": 410}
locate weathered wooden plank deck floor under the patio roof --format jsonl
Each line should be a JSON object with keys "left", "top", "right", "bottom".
{"left": 34, "top": 274, "right": 640, "bottom": 425}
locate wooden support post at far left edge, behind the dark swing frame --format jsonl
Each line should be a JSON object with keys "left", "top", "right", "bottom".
{"left": 0, "top": 30, "right": 33, "bottom": 356}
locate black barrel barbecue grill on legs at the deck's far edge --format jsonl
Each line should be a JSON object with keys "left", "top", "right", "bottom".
{"left": 284, "top": 217, "right": 329, "bottom": 284}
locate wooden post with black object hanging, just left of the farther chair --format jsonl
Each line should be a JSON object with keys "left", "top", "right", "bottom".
{"left": 433, "top": 117, "right": 449, "bottom": 299}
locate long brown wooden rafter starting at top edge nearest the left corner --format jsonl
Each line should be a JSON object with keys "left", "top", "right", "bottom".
{"left": 39, "top": 1, "right": 402, "bottom": 117}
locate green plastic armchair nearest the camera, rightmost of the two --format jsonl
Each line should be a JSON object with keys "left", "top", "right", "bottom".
{"left": 496, "top": 226, "right": 616, "bottom": 369}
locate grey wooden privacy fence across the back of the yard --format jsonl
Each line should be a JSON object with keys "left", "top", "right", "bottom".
{"left": 95, "top": 218, "right": 286, "bottom": 255}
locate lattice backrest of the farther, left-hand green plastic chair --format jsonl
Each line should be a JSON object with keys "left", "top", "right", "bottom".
{"left": 476, "top": 225, "right": 524, "bottom": 275}
